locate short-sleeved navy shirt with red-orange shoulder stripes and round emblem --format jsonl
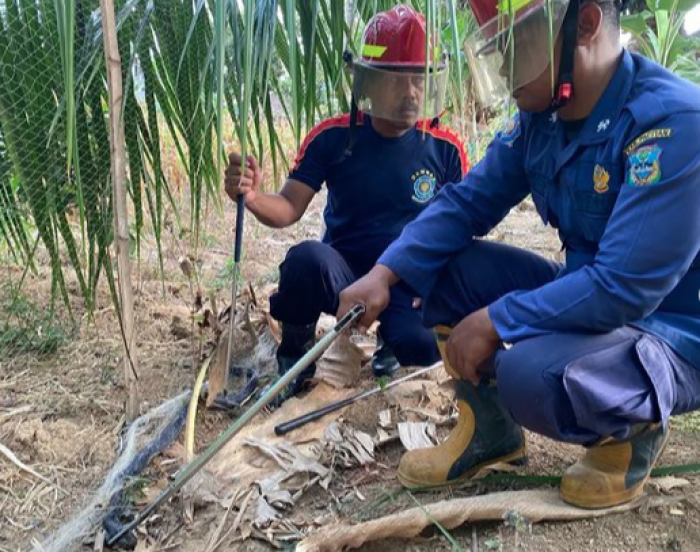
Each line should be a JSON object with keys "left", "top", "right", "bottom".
{"left": 289, "top": 114, "right": 467, "bottom": 272}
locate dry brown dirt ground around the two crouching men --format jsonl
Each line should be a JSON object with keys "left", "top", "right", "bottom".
{"left": 0, "top": 189, "right": 700, "bottom": 552}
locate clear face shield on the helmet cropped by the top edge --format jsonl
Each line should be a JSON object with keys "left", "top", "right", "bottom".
{"left": 465, "top": 0, "right": 569, "bottom": 106}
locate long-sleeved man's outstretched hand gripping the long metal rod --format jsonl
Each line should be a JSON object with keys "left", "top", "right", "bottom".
{"left": 336, "top": 265, "right": 399, "bottom": 332}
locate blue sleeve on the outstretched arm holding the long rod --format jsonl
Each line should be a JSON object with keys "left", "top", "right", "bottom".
{"left": 378, "top": 113, "right": 529, "bottom": 297}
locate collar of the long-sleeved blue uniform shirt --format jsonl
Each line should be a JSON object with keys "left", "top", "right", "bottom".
{"left": 537, "top": 49, "right": 635, "bottom": 145}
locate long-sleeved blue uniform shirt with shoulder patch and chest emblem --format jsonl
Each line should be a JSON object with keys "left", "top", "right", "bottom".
{"left": 379, "top": 51, "right": 700, "bottom": 368}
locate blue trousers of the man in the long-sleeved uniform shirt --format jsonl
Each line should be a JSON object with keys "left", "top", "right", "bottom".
{"left": 424, "top": 241, "right": 700, "bottom": 446}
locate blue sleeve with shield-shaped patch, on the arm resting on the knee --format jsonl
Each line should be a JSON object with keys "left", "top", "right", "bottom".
{"left": 489, "top": 114, "right": 700, "bottom": 342}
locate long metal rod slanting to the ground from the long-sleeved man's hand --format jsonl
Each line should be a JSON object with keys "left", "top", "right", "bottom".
{"left": 107, "top": 305, "right": 365, "bottom": 546}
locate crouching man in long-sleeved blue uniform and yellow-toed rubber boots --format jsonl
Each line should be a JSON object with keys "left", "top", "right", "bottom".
{"left": 338, "top": 0, "right": 700, "bottom": 508}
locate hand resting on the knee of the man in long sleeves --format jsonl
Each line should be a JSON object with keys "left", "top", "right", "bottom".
{"left": 447, "top": 308, "right": 501, "bottom": 385}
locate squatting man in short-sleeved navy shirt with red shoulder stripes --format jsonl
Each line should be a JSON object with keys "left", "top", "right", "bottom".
{"left": 225, "top": 6, "right": 467, "bottom": 406}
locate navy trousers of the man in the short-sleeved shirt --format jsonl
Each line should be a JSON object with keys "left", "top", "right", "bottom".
{"left": 270, "top": 241, "right": 440, "bottom": 366}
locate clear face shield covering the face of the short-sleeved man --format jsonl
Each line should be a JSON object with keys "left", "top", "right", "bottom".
{"left": 352, "top": 61, "right": 447, "bottom": 124}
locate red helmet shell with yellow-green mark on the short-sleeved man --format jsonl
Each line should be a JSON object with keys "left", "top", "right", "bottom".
{"left": 360, "top": 5, "right": 426, "bottom": 68}
